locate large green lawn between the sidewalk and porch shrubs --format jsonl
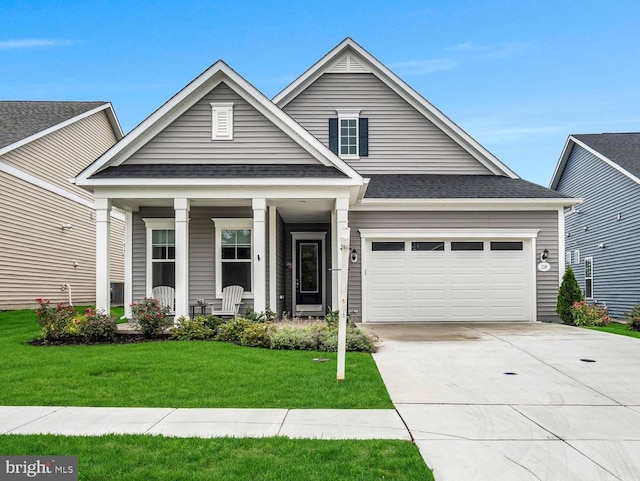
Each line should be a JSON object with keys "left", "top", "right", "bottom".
{"left": 0, "top": 311, "right": 393, "bottom": 409}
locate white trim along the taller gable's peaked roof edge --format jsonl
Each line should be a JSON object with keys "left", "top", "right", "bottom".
{"left": 273, "top": 37, "right": 519, "bottom": 179}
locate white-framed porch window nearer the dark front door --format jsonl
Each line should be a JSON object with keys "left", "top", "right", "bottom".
{"left": 212, "top": 219, "right": 253, "bottom": 297}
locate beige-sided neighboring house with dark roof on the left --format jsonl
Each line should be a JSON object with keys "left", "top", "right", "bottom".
{"left": 0, "top": 101, "right": 124, "bottom": 310}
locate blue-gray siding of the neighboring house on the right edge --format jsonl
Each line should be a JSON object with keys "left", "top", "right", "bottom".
{"left": 557, "top": 146, "right": 640, "bottom": 319}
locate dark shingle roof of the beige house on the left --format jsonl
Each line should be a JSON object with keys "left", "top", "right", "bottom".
{"left": 0, "top": 100, "right": 106, "bottom": 148}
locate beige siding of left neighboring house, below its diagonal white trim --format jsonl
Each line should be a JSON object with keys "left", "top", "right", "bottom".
{"left": 0, "top": 172, "right": 124, "bottom": 310}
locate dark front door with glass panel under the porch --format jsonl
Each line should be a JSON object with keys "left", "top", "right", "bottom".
{"left": 295, "top": 239, "right": 324, "bottom": 311}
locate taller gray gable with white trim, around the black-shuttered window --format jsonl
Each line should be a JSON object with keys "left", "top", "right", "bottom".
{"left": 274, "top": 38, "right": 518, "bottom": 179}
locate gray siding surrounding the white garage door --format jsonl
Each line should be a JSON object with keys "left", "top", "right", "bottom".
{"left": 348, "top": 211, "right": 559, "bottom": 321}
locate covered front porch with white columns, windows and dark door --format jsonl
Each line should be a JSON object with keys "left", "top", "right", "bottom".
{"left": 96, "top": 186, "right": 350, "bottom": 318}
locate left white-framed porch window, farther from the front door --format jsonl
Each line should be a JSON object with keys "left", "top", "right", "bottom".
{"left": 143, "top": 218, "right": 176, "bottom": 293}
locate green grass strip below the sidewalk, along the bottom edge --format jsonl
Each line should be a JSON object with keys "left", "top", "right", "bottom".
{"left": 0, "top": 435, "right": 433, "bottom": 481}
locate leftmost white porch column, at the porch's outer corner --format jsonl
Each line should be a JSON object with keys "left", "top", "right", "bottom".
{"left": 95, "top": 199, "right": 111, "bottom": 313}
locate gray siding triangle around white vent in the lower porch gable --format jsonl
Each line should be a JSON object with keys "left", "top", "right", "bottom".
{"left": 125, "top": 83, "right": 318, "bottom": 164}
